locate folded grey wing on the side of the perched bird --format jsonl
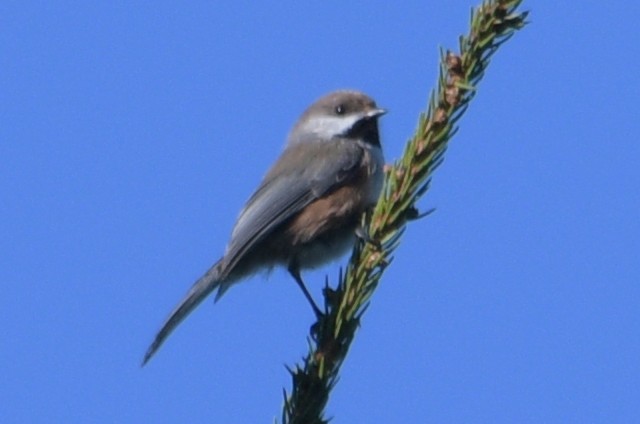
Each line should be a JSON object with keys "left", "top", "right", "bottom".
{"left": 223, "top": 139, "right": 364, "bottom": 275}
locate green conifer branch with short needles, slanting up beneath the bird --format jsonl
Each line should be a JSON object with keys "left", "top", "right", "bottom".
{"left": 282, "top": 0, "right": 528, "bottom": 424}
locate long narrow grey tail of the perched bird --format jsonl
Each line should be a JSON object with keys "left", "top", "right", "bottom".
{"left": 142, "top": 261, "right": 230, "bottom": 366}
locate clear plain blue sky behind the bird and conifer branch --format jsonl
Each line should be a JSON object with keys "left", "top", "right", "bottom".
{"left": 0, "top": 0, "right": 640, "bottom": 423}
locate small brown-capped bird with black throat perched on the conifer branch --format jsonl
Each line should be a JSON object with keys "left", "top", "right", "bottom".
{"left": 142, "top": 90, "right": 386, "bottom": 366}
